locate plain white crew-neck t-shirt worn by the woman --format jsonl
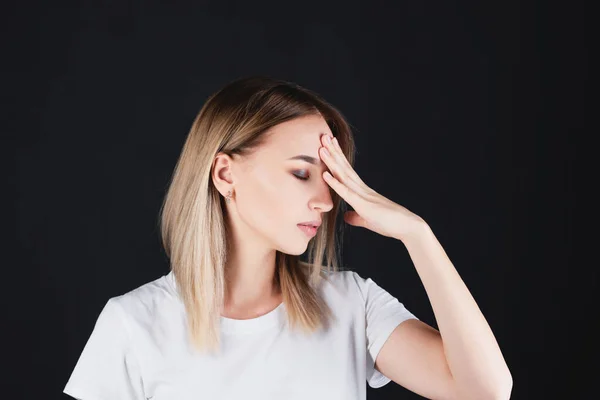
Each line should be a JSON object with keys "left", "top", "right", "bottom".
{"left": 63, "top": 271, "right": 418, "bottom": 400}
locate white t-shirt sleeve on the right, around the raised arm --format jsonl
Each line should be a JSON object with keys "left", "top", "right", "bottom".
{"left": 352, "top": 272, "right": 418, "bottom": 388}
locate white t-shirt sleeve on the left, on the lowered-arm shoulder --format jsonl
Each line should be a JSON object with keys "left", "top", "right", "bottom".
{"left": 63, "top": 298, "right": 146, "bottom": 400}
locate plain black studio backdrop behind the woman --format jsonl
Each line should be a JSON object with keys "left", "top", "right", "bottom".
{"left": 7, "top": 1, "right": 584, "bottom": 399}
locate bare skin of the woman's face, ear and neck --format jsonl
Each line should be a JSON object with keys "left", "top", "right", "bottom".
{"left": 212, "top": 116, "right": 333, "bottom": 319}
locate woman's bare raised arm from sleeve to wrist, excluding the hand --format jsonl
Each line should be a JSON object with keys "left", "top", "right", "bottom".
{"left": 376, "top": 223, "right": 512, "bottom": 400}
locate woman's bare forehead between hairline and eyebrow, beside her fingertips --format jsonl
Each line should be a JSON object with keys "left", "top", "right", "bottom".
{"left": 265, "top": 115, "right": 331, "bottom": 157}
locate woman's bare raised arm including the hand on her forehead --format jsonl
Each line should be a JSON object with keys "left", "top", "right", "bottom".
{"left": 319, "top": 134, "right": 512, "bottom": 400}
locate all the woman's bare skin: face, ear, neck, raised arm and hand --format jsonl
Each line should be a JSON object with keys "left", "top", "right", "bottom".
{"left": 213, "top": 117, "right": 512, "bottom": 400}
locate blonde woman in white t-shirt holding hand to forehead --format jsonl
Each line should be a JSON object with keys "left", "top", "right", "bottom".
{"left": 64, "top": 77, "right": 512, "bottom": 400}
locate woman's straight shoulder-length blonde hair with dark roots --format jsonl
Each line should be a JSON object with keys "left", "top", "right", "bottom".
{"left": 159, "top": 77, "right": 355, "bottom": 351}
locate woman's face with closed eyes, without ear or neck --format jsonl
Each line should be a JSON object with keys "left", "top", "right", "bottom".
{"left": 226, "top": 116, "right": 333, "bottom": 255}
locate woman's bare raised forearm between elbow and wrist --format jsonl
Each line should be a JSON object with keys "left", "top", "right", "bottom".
{"left": 402, "top": 223, "right": 512, "bottom": 399}
